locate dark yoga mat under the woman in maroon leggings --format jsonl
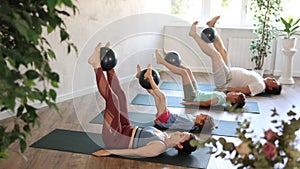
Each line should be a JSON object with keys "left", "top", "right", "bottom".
{"left": 31, "top": 129, "right": 211, "bottom": 168}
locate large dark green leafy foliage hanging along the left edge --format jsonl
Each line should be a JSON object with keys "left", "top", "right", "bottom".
{"left": 0, "top": 0, "right": 77, "bottom": 159}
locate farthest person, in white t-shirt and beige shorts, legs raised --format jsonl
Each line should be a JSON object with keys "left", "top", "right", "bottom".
{"left": 189, "top": 16, "right": 282, "bottom": 96}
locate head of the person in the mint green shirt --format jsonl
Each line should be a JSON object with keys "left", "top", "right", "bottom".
{"left": 226, "top": 92, "right": 246, "bottom": 108}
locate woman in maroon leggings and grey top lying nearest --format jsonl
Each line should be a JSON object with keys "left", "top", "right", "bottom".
{"left": 88, "top": 42, "right": 197, "bottom": 157}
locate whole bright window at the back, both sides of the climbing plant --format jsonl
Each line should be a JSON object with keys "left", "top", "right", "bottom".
{"left": 170, "top": 0, "right": 300, "bottom": 26}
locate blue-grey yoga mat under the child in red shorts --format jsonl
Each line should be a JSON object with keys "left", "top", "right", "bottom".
{"left": 90, "top": 111, "right": 239, "bottom": 137}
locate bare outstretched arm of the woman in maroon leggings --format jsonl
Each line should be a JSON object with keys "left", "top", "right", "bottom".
{"left": 92, "top": 141, "right": 166, "bottom": 157}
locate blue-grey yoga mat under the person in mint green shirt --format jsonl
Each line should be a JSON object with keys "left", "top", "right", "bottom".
{"left": 131, "top": 94, "right": 260, "bottom": 114}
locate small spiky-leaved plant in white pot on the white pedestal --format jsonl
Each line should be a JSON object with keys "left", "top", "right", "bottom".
{"left": 280, "top": 17, "right": 300, "bottom": 49}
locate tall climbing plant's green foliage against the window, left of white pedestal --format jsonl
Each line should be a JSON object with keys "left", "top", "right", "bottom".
{"left": 250, "top": 0, "right": 282, "bottom": 69}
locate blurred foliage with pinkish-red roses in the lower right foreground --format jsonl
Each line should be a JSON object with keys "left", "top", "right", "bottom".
{"left": 192, "top": 109, "right": 300, "bottom": 169}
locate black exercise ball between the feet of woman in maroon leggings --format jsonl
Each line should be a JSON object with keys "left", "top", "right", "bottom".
{"left": 100, "top": 47, "right": 117, "bottom": 71}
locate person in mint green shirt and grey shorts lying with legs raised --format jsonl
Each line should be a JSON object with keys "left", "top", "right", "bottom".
{"left": 155, "top": 49, "right": 246, "bottom": 108}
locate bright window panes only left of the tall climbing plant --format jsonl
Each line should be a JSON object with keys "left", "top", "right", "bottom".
{"left": 171, "top": 0, "right": 249, "bottom": 25}
